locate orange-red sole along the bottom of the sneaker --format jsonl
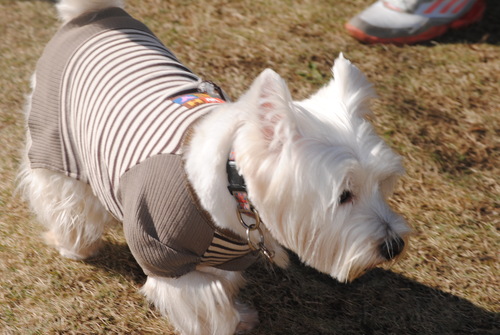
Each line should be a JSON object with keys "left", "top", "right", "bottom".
{"left": 345, "top": 1, "right": 486, "bottom": 44}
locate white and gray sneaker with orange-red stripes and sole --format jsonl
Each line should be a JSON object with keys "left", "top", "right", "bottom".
{"left": 345, "top": 0, "right": 486, "bottom": 44}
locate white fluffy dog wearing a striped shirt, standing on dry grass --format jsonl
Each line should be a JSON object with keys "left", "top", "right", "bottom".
{"left": 21, "top": 0, "right": 409, "bottom": 335}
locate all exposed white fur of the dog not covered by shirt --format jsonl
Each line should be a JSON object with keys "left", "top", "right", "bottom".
{"left": 20, "top": 0, "right": 409, "bottom": 335}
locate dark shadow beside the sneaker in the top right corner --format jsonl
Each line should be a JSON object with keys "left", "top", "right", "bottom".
{"left": 425, "top": 0, "right": 500, "bottom": 45}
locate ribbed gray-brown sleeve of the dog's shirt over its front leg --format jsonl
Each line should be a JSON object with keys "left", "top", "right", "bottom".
{"left": 120, "top": 154, "right": 217, "bottom": 277}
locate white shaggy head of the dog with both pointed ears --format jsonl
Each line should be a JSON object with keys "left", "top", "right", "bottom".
{"left": 234, "top": 55, "right": 409, "bottom": 281}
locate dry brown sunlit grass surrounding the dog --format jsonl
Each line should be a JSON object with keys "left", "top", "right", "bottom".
{"left": 0, "top": 0, "right": 500, "bottom": 334}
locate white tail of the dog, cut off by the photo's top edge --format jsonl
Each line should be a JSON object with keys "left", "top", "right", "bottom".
{"left": 56, "top": 0, "right": 124, "bottom": 23}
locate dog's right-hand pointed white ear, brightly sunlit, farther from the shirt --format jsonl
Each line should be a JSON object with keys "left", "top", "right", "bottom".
{"left": 330, "top": 53, "right": 376, "bottom": 118}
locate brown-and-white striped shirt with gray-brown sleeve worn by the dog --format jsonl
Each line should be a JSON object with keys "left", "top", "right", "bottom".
{"left": 28, "top": 8, "right": 257, "bottom": 277}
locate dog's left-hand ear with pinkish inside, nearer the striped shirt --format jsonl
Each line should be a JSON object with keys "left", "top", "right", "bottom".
{"left": 244, "top": 69, "right": 296, "bottom": 149}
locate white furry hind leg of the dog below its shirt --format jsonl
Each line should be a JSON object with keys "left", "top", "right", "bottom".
{"left": 19, "top": 151, "right": 112, "bottom": 260}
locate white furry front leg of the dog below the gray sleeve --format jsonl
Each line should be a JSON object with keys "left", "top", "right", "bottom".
{"left": 141, "top": 267, "right": 258, "bottom": 335}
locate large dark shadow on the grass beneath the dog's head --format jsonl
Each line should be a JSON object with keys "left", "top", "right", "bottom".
{"left": 242, "top": 258, "right": 500, "bottom": 335}
